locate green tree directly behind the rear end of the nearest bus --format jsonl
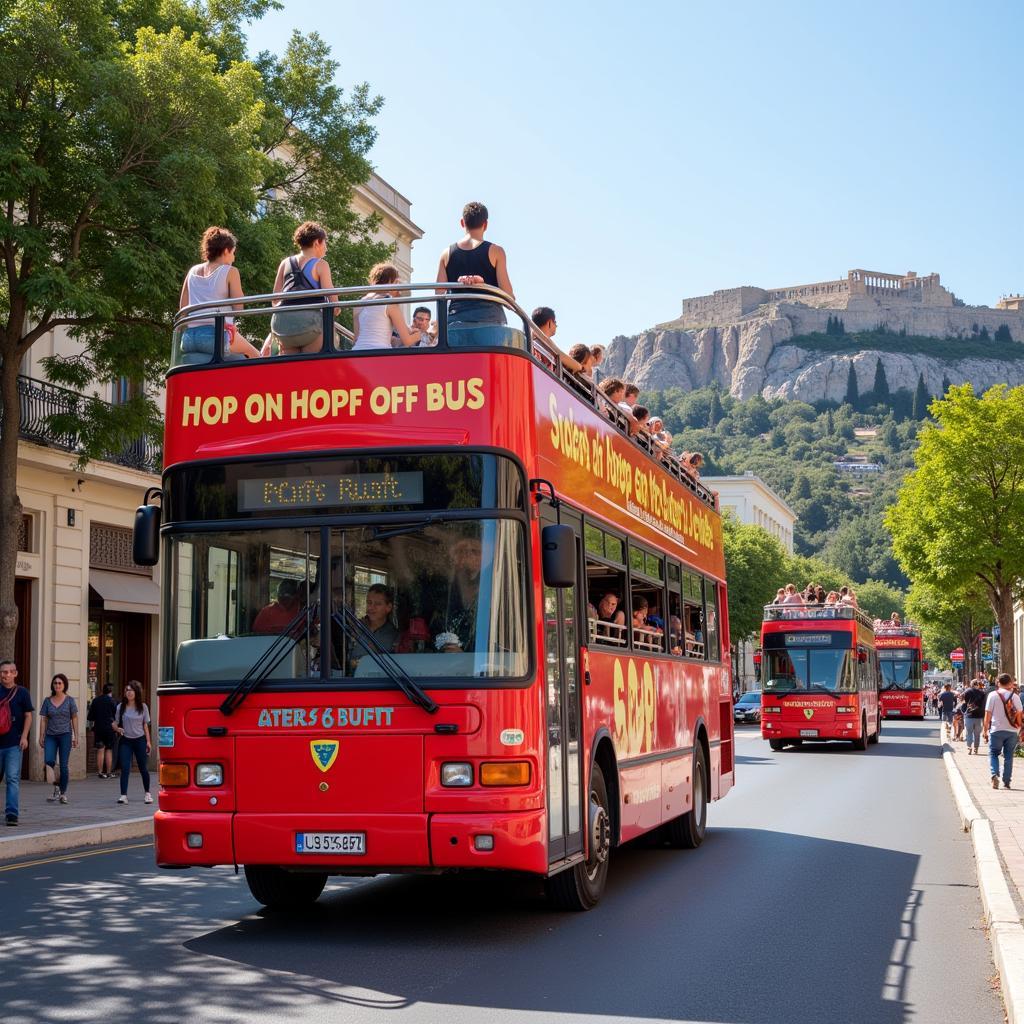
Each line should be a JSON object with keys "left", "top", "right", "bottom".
{"left": 722, "top": 514, "right": 785, "bottom": 641}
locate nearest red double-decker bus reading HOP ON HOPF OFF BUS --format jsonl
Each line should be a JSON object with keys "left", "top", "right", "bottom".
{"left": 136, "top": 285, "right": 734, "bottom": 909}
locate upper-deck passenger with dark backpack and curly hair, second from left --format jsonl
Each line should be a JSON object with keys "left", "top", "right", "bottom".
{"left": 262, "top": 220, "right": 338, "bottom": 355}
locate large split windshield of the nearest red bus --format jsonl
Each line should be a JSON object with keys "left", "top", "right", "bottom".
{"left": 164, "top": 517, "right": 529, "bottom": 684}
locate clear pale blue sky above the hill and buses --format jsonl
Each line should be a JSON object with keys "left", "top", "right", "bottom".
{"left": 250, "top": 0, "right": 1024, "bottom": 347}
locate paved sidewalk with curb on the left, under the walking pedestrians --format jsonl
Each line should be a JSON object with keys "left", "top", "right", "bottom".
{"left": 0, "top": 772, "right": 157, "bottom": 861}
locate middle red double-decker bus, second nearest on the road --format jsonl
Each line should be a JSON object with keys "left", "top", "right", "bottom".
{"left": 761, "top": 604, "right": 882, "bottom": 751}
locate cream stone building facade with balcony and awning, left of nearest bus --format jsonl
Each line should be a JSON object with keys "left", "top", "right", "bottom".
{"left": 14, "top": 167, "right": 423, "bottom": 779}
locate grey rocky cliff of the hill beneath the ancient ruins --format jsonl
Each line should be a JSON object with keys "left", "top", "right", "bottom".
{"left": 602, "top": 296, "right": 1024, "bottom": 402}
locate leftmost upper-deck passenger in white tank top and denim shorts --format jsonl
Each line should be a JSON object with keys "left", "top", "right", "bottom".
{"left": 178, "top": 227, "right": 259, "bottom": 358}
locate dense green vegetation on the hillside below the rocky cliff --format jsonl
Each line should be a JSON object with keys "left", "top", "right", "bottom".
{"left": 641, "top": 385, "right": 924, "bottom": 590}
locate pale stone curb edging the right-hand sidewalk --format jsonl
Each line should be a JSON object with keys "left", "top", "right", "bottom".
{"left": 942, "top": 743, "right": 1024, "bottom": 1024}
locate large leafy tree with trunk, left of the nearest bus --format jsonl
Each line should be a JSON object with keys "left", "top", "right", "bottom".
{"left": 0, "top": 0, "right": 386, "bottom": 656}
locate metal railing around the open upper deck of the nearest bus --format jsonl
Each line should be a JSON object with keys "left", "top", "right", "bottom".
{"left": 172, "top": 281, "right": 718, "bottom": 510}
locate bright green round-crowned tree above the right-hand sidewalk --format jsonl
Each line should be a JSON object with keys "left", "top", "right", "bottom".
{"left": 886, "top": 384, "right": 1024, "bottom": 671}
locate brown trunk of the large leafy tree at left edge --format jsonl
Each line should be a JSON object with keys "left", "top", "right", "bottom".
{"left": 0, "top": 352, "right": 22, "bottom": 659}
